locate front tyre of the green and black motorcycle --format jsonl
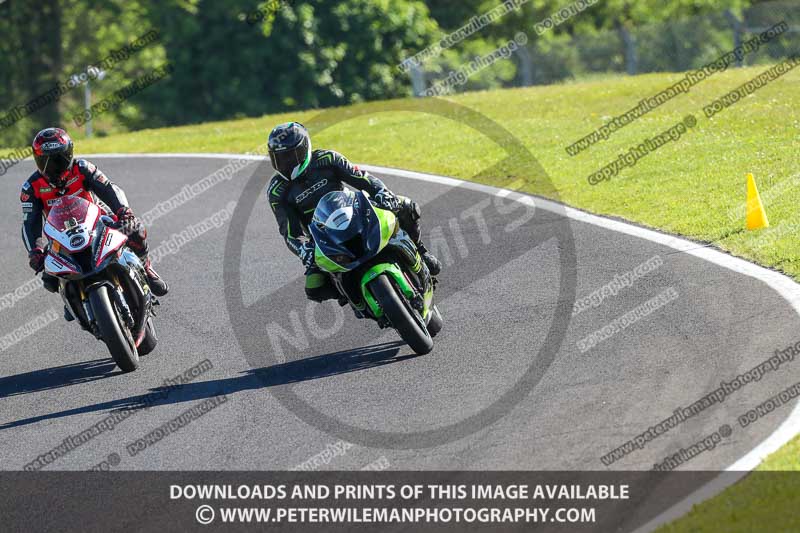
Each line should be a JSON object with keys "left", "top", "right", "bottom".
{"left": 368, "top": 274, "right": 433, "bottom": 355}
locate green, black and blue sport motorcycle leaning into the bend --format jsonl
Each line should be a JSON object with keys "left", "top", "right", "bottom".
{"left": 310, "top": 190, "right": 442, "bottom": 355}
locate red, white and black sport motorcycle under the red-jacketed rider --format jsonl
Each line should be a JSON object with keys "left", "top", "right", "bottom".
{"left": 44, "top": 196, "right": 158, "bottom": 372}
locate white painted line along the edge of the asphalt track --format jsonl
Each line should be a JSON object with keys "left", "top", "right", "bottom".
{"left": 85, "top": 153, "right": 800, "bottom": 532}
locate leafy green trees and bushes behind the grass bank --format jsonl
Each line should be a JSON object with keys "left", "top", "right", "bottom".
{"left": 0, "top": 0, "right": 800, "bottom": 146}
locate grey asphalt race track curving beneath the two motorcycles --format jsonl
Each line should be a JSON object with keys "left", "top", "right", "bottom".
{"left": 0, "top": 157, "right": 800, "bottom": 478}
